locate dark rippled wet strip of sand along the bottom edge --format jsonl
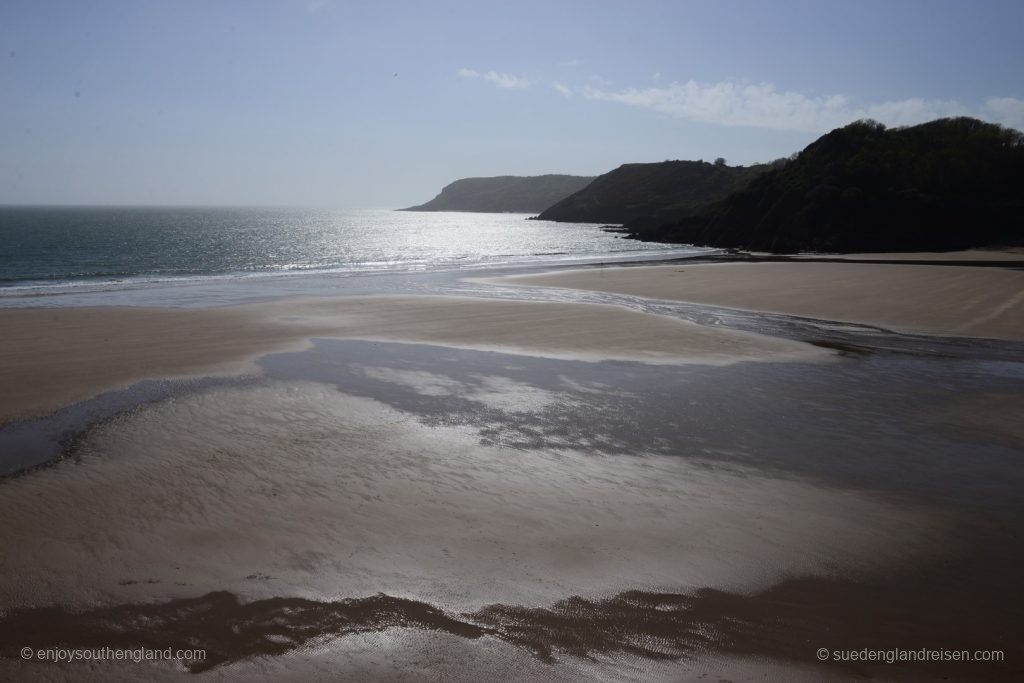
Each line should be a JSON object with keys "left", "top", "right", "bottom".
{"left": 0, "top": 579, "right": 1024, "bottom": 680}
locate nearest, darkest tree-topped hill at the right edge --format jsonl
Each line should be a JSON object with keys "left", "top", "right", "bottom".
{"left": 631, "top": 118, "right": 1024, "bottom": 252}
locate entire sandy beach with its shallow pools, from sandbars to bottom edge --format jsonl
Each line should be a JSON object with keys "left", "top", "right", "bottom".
{"left": 0, "top": 263, "right": 1024, "bottom": 680}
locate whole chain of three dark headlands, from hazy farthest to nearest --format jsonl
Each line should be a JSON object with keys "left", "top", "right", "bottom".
{"left": 403, "top": 117, "right": 1024, "bottom": 253}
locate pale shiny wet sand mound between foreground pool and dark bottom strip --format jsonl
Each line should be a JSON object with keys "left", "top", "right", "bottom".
{"left": 0, "top": 376, "right": 947, "bottom": 610}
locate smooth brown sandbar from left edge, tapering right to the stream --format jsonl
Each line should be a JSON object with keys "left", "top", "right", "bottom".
{"left": 0, "top": 296, "right": 825, "bottom": 423}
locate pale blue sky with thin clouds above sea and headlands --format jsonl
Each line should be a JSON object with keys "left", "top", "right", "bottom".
{"left": 0, "top": 0, "right": 1024, "bottom": 208}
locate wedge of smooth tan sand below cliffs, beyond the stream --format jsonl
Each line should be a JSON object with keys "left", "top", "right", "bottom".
{"left": 488, "top": 260, "right": 1024, "bottom": 341}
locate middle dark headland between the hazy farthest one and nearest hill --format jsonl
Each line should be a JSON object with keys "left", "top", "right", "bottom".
{"left": 539, "top": 161, "right": 767, "bottom": 224}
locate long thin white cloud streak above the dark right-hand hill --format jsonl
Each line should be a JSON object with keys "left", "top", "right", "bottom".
{"left": 580, "top": 81, "right": 1024, "bottom": 132}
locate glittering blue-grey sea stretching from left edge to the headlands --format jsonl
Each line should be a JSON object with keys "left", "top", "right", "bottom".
{"left": 0, "top": 207, "right": 699, "bottom": 305}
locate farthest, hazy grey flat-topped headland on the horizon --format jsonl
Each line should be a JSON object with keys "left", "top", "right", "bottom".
{"left": 401, "top": 175, "right": 594, "bottom": 213}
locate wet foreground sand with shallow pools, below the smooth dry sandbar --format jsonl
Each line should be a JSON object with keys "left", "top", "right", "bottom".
{"left": 0, "top": 340, "right": 1024, "bottom": 680}
